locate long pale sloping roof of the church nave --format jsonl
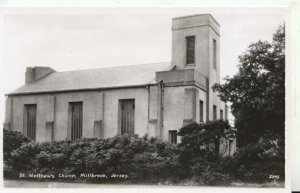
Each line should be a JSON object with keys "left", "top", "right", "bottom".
{"left": 7, "top": 63, "right": 171, "bottom": 95}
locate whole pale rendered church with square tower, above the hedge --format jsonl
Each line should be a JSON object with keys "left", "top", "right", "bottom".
{"left": 4, "top": 14, "right": 234, "bottom": 154}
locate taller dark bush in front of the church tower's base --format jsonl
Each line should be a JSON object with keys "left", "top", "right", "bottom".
{"left": 178, "top": 120, "right": 235, "bottom": 185}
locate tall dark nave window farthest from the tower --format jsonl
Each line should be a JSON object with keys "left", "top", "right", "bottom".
{"left": 24, "top": 104, "right": 36, "bottom": 141}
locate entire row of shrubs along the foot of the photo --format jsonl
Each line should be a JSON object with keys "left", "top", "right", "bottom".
{"left": 3, "top": 125, "right": 284, "bottom": 186}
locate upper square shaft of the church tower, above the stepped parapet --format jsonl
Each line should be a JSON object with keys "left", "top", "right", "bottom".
{"left": 172, "top": 14, "right": 220, "bottom": 83}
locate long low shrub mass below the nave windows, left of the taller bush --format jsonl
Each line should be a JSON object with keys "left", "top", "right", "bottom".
{"left": 4, "top": 135, "right": 180, "bottom": 183}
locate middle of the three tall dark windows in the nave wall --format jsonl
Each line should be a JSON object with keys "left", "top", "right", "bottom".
{"left": 69, "top": 102, "right": 82, "bottom": 141}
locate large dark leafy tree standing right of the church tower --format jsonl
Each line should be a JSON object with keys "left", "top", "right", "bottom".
{"left": 213, "top": 25, "right": 285, "bottom": 149}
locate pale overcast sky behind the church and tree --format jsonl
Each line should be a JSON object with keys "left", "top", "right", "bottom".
{"left": 0, "top": 8, "right": 287, "bottom": 123}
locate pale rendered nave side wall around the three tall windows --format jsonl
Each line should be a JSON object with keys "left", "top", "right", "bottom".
{"left": 6, "top": 88, "right": 148, "bottom": 142}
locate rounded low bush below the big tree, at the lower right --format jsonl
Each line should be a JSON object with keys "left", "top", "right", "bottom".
{"left": 222, "top": 138, "right": 285, "bottom": 183}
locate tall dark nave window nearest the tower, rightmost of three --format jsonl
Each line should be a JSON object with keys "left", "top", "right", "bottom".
{"left": 119, "top": 99, "right": 135, "bottom": 135}
